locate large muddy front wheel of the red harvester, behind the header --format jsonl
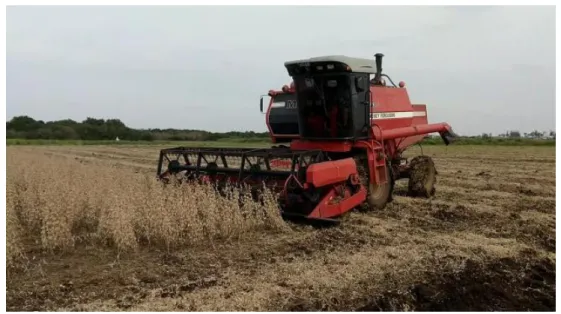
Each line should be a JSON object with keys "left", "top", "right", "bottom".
{"left": 357, "top": 160, "right": 393, "bottom": 212}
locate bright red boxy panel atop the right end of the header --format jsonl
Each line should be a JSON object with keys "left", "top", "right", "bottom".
{"left": 306, "top": 158, "right": 357, "bottom": 187}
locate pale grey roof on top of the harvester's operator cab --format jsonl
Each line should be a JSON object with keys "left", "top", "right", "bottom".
{"left": 284, "top": 55, "right": 376, "bottom": 75}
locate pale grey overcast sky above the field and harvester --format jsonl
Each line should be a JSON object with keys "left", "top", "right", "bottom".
{"left": 6, "top": 6, "right": 555, "bottom": 135}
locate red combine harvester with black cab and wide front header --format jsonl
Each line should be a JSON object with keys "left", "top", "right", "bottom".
{"left": 157, "top": 54, "right": 456, "bottom": 221}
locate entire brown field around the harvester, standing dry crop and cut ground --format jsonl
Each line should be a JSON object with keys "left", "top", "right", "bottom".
{"left": 6, "top": 142, "right": 556, "bottom": 311}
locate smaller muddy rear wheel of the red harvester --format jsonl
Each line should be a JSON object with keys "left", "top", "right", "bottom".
{"left": 407, "top": 156, "right": 437, "bottom": 198}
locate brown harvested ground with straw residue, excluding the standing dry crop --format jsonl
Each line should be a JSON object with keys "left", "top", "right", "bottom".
{"left": 7, "top": 146, "right": 556, "bottom": 311}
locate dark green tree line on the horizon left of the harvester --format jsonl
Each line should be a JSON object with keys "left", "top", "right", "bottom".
{"left": 6, "top": 116, "right": 269, "bottom": 141}
